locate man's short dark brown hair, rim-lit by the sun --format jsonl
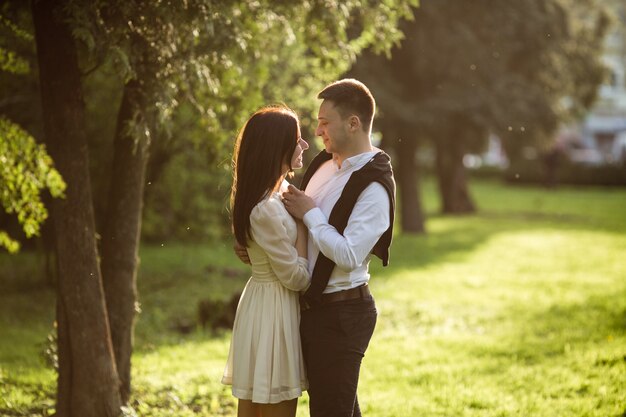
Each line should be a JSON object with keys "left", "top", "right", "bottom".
{"left": 317, "top": 78, "right": 376, "bottom": 132}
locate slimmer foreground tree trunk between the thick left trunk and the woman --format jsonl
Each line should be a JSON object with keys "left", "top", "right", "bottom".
{"left": 102, "top": 80, "right": 149, "bottom": 404}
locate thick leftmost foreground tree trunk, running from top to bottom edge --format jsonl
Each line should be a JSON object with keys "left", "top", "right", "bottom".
{"left": 32, "top": 0, "right": 121, "bottom": 417}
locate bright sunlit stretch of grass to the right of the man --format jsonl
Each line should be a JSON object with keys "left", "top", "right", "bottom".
{"left": 360, "top": 214, "right": 626, "bottom": 416}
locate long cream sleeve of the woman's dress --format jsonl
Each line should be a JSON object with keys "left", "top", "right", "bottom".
{"left": 250, "top": 199, "right": 311, "bottom": 291}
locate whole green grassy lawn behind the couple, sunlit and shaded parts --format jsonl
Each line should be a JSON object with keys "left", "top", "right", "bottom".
{"left": 0, "top": 181, "right": 626, "bottom": 417}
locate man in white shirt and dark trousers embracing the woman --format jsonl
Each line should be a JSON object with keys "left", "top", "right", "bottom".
{"left": 283, "top": 79, "right": 395, "bottom": 417}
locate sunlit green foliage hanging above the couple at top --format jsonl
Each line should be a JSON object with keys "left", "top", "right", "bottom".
{"left": 69, "top": 0, "right": 417, "bottom": 155}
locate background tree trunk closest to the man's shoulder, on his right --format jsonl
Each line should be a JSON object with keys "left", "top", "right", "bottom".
{"left": 385, "top": 128, "right": 426, "bottom": 233}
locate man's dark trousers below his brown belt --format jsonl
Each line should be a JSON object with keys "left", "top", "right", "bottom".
{"left": 300, "top": 296, "right": 377, "bottom": 417}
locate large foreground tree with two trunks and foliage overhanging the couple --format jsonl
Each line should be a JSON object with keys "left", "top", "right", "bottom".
{"left": 17, "top": 0, "right": 410, "bottom": 416}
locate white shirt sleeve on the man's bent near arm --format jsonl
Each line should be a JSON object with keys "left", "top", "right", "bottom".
{"left": 303, "top": 182, "right": 391, "bottom": 272}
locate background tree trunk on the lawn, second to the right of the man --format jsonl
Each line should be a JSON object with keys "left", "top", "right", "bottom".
{"left": 435, "top": 134, "right": 476, "bottom": 213}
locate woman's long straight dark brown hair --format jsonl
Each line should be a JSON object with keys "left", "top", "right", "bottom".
{"left": 230, "top": 106, "right": 299, "bottom": 247}
